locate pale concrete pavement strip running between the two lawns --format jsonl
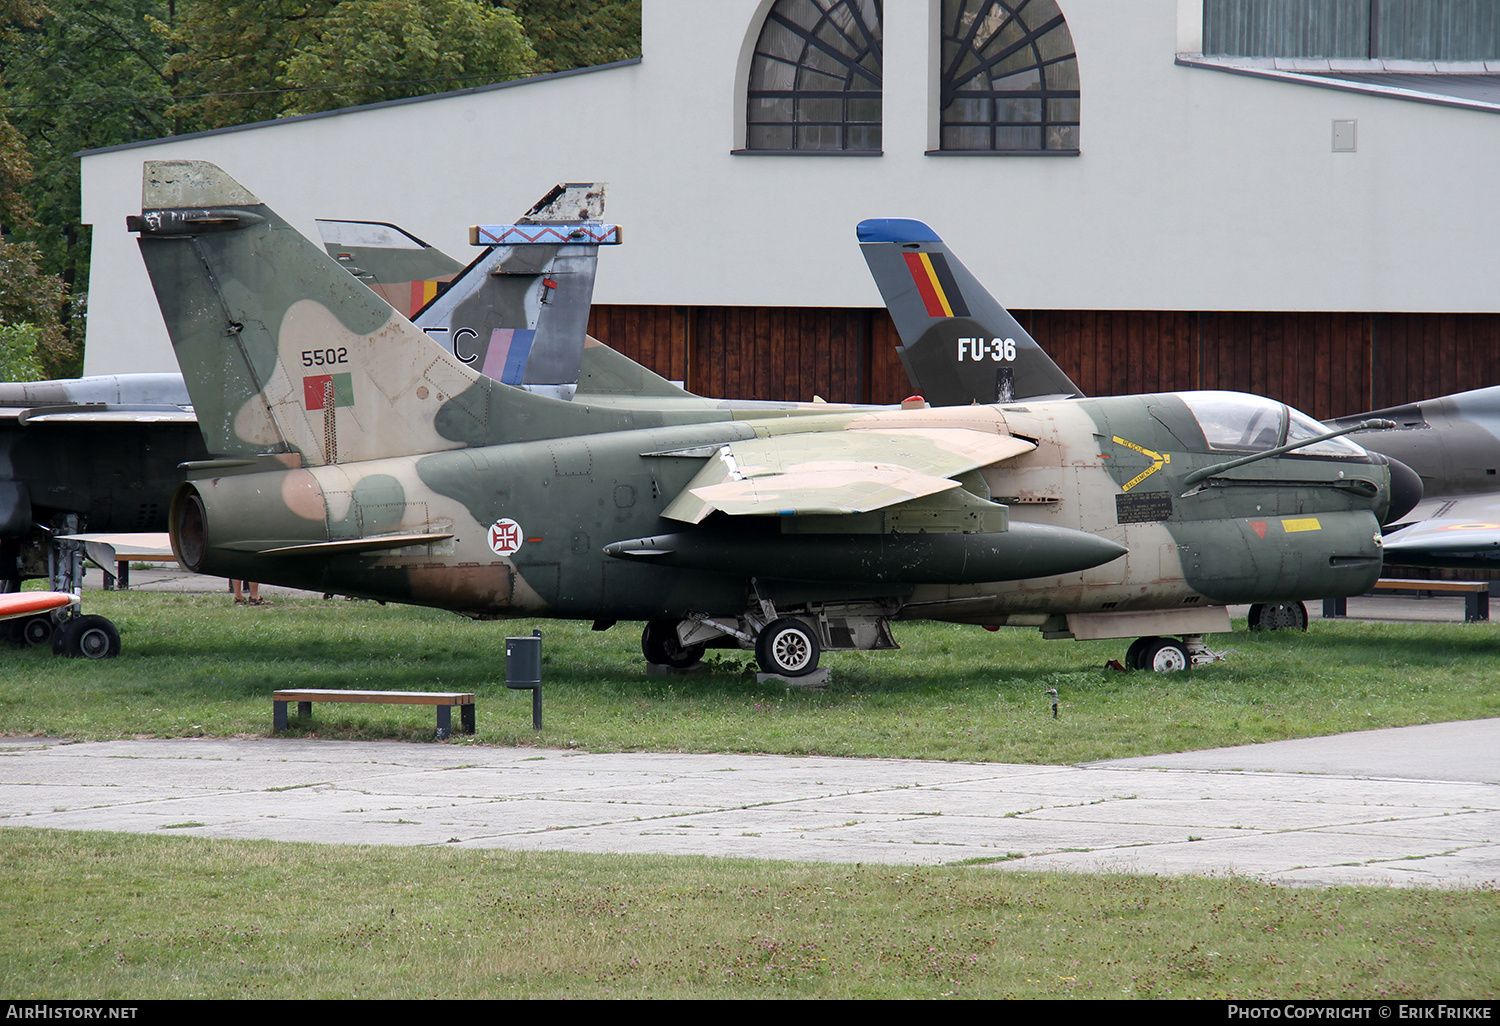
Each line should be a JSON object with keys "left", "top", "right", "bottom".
{"left": 0, "top": 719, "right": 1500, "bottom": 887}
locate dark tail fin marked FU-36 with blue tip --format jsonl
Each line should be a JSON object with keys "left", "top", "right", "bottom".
{"left": 858, "top": 218, "right": 1083, "bottom": 407}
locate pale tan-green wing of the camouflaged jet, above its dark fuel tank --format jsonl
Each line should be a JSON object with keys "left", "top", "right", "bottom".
{"left": 662, "top": 428, "right": 1035, "bottom": 524}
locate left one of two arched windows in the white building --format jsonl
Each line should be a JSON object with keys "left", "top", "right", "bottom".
{"left": 746, "top": 0, "right": 882, "bottom": 153}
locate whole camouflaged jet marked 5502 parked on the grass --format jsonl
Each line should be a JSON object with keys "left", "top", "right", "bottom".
{"left": 129, "top": 161, "right": 1410, "bottom": 675}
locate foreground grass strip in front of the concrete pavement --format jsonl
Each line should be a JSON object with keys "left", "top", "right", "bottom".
{"left": 0, "top": 830, "right": 1500, "bottom": 1001}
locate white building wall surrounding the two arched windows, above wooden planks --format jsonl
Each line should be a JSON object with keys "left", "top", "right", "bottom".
{"left": 83, "top": 0, "right": 1500, "bottom": 374}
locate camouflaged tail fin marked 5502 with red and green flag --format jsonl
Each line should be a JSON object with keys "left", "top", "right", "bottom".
{"left": 128, "top": 161, "right": 636, "bottom": 467}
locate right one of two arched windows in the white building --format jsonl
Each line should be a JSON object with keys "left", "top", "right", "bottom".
{"left": 939, "top": 0, "right": 1079, "bottom": 153}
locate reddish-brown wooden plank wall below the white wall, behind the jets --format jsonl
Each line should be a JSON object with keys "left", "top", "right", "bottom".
{"left": 590, "top": 306, "right": 1500, "bottom": 419}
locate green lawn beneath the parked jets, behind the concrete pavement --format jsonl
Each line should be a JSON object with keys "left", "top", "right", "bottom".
{"left": 0, "top": 593, "right": 1500, "bottom": 764}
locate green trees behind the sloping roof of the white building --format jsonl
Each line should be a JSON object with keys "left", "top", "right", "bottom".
{"left": 0, "top": 0, "right": 641, "bottom": 374}
